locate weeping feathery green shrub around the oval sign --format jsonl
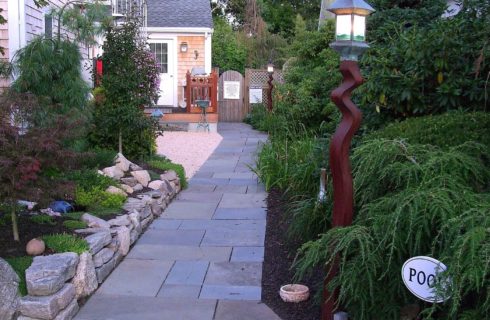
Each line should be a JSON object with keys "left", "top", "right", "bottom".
{"left": 296, "top": 140, "right": 490, "bottom": 320}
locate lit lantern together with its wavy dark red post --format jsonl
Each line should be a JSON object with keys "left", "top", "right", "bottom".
{"left": 322, "top": 0, "right": 374, "bottom": 320}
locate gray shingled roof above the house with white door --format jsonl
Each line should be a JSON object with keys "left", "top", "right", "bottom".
{"left": 147, "top": 0, "right": 213, "bottom": 28}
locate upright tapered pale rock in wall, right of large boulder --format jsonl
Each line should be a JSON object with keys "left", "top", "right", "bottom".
{"left": 72, "top": 252, "right": 99, "bottom": 299}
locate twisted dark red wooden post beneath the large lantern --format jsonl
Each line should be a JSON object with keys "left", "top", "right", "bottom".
{"left": 322, "top": 61, "right": 364, "bottom": 320}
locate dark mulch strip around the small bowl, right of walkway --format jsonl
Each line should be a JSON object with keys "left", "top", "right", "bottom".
{"left": 262, "top": 190, "right": 324, "bottom": 320}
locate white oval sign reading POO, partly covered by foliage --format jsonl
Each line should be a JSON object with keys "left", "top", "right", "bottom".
{"left": 402, "top": 256, "right": 450, "bottom": 303}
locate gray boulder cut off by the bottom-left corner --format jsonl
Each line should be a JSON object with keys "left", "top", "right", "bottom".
{"left": 0, "top": 258, "right": 20, "bottom": 320}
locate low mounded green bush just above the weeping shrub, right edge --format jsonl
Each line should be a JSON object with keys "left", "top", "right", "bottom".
{"left": 364, "top": 111, "right": 490, "bottom": 148}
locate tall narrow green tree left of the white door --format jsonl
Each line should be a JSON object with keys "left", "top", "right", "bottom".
{"left": 91, "top": 18, "right": 159, "bottom": 158}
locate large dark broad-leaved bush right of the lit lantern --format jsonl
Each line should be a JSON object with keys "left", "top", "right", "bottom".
{"left": 359, "top": 0, "right": 490, "bottom": 118}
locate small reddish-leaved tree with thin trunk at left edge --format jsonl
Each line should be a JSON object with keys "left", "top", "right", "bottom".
{"left": 0, "top": 91, "right": 77, "bottom": 241}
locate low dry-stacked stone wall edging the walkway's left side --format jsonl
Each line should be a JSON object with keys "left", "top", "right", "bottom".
{"left": 0, "top": 159, "right": 180, "bottom": 320}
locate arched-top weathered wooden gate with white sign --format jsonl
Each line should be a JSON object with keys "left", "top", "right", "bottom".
{"left": 218, "top": 71, "right": 247, "bottom": 122}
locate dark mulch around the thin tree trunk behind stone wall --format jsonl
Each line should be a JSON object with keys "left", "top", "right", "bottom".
{"left": 0, "top": 214, "right": 72, "bottom": 258}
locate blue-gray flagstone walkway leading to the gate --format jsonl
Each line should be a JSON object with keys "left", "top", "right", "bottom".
{"left": 75, "top": 123, "right": 280, "bottom": 320}
